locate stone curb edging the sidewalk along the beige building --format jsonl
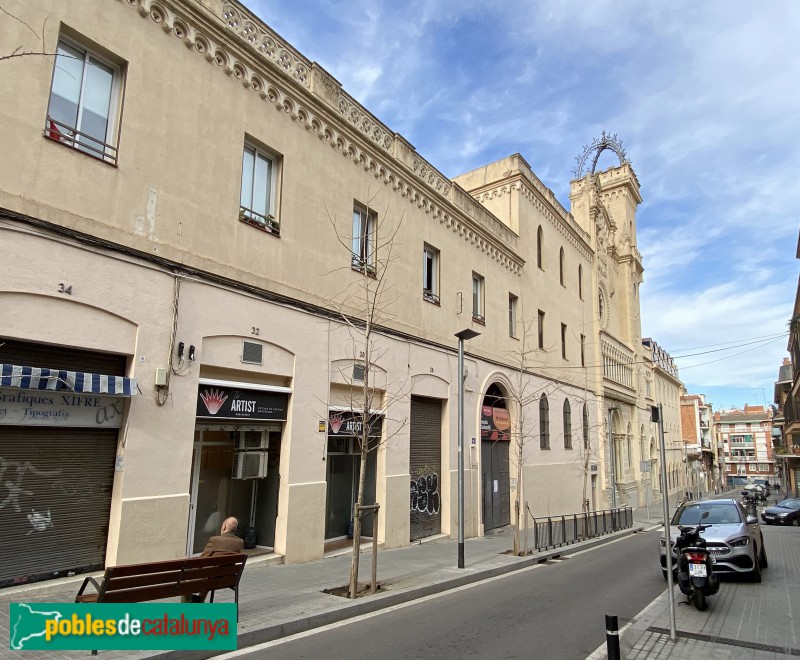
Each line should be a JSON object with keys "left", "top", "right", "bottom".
{"left": 148, "top": 525, "right": 644, "bottom": 660}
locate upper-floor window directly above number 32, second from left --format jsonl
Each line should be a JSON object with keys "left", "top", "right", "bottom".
{"left": 239, "top": 145, "right": 280, "bottom": 234}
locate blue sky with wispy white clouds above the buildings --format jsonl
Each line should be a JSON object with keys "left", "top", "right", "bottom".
{"left": 245, "top": 0, "right": 800, "bottom": 410}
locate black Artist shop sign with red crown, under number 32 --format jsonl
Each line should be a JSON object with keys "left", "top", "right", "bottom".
{"left": 197, "top": 385, "right": 287, "bottom": 422}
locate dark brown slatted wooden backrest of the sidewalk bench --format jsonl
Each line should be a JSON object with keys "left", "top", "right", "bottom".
{"left": 97, "top": 553, "right": 247, "bottom": 603}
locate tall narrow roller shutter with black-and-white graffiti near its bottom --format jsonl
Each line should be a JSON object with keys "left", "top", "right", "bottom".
{"left": 409, "top": 396, "right": 442, "bottom": 541}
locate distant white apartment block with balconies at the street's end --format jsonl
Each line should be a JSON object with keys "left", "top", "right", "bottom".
{"left": 714, "top": 404, "right": 775, "bottom": 485}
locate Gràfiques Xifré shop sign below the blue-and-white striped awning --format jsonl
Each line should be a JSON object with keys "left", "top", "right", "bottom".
{"left": 0, "top": 388, "right": 125, "bottom": 429}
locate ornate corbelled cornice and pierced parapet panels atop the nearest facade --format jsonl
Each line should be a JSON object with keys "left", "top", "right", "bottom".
{"left": 120, "top": 0, "right": 524, "bottom": 275}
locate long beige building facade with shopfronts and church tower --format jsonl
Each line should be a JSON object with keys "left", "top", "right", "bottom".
{"left": 0, "top": 0, "right": 680, "bottom": 586}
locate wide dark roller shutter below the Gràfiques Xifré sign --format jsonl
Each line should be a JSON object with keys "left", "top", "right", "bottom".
{"left": 0, "top": 426, "right": 118, "bottom": 587}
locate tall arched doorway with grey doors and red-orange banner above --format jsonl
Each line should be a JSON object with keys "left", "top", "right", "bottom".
{"left": 481, "top": 384, "right": 511, "bottom": 530}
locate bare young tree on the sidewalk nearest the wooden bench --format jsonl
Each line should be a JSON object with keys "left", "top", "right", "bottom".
{"left": 320, "top": 196, "right": 407, "bottom": 598}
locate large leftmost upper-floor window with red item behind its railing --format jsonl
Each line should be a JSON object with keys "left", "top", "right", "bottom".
{"left": 44, "top": 37, "right": 122, "bottom": 165}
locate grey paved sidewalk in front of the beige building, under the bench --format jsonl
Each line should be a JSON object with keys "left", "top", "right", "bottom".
{"left": 0, "top": 524, "right": 642, "bottom": 660}
